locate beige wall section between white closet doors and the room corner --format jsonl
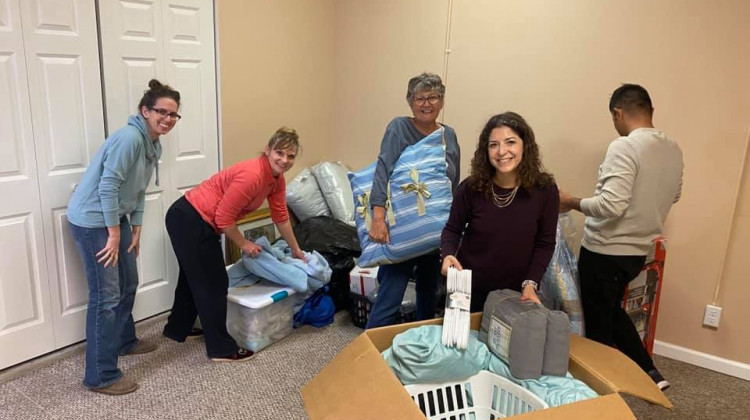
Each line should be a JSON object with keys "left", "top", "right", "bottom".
{"left": 216, "top": 0, "right": 335, "bottom": 174}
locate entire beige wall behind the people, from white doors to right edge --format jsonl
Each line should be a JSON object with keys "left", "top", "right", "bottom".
{"left": 219, "top": 0, "right": 750, "bottom": 363}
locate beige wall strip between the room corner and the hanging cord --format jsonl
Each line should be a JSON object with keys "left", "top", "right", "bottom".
{"left": 332, "top": 0, "right": 450, "bottom": 169}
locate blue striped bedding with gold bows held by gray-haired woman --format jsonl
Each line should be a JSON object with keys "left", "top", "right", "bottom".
{"left": 349, "top": 127, "right": 453, "bottom": 267}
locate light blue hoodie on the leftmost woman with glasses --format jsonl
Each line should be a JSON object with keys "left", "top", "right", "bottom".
{"left": 67, "top": 115, "right": 161, "bottom": 228}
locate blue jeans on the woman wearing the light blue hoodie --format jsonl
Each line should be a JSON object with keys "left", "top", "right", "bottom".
{"left": 70, "top": 217, "right": 138, "bottom": 388}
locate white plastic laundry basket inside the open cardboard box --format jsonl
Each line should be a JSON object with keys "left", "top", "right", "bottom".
{"left": 405, "top": 370, "right": 548, "bottom": 420}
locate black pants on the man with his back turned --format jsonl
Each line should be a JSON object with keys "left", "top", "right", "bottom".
{"left": 578, "top": 247, "right": 654, "bottom": 372}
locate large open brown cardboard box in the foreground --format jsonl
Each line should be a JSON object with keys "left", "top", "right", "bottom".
{"left": 302, "top": 313, "right": 673, "bottom": 420}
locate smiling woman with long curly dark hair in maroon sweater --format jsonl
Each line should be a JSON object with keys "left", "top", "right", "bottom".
{"left": 440, "top": 112, "right": 559, "bottom": 312}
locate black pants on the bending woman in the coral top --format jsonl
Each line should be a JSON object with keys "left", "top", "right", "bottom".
{"left": 164, "top": 197, "right": 237, "bottom": 357}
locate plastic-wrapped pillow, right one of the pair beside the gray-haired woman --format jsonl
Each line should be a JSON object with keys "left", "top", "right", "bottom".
{"left": 310, "top": 162, "right": 354, "bottom": 225}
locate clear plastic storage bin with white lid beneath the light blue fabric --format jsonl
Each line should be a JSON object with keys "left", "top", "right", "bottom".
{"left": 227, "top": 280, "right": 295, "bottom": 352}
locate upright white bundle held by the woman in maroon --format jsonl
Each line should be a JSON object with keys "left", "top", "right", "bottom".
{"left": 442, "top": 267, "right": 471, "bottom": 349}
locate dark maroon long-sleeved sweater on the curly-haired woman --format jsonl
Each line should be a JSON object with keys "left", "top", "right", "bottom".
{"left": 440, "top": 180, "right": 560, "bottom": 307}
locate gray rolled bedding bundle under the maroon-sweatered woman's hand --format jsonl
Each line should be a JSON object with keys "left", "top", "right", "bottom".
{"left": 479, "top": 289, "right": 570, "bottom": 379}
